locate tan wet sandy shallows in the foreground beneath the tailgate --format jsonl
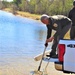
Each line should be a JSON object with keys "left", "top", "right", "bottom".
{"left": 0, "top": 57, "right": 73, "bottom": 75}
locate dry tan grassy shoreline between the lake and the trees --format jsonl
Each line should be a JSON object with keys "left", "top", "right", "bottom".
{"left": 2, "top": 8, "right": 41, "bottom": 20}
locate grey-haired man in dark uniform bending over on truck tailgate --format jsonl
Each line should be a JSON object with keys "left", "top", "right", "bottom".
{"left": 41, "top": 14, "right": 71, "bottom": 58}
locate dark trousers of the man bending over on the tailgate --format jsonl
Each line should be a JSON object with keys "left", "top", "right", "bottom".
{"left": 51, "top": 24, "right": 71, "bottom": 54}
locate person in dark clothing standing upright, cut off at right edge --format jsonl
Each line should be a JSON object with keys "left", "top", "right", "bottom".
{"left": 68, "top": 1, "right": 75, "bottom": 39}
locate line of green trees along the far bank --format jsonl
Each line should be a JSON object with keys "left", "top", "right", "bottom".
{"left": 0, "top": 0, "right": 73, "bottom": 15}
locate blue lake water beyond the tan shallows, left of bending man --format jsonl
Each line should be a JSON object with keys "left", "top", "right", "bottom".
{"left": 0, "top": 11, "right": 51, "bottom": 57}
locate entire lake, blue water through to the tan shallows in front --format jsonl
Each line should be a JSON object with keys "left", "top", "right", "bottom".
{"left": 0, "top": 10, "right": 63, "bottom": 75}
